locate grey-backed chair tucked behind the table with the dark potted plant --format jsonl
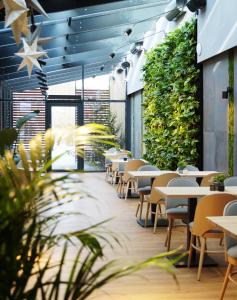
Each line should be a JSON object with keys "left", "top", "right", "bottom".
{"left": 165, "top": 177, "right": 199, "bottom": 251}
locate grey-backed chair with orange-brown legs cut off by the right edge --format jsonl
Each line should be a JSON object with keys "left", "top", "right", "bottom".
{"left": 220, "top": 200, "right": 237, "bottom": 300}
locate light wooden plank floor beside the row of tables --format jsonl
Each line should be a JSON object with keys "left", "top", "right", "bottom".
{"left": 56, "top": 173, "right": 237, "bottom": 300}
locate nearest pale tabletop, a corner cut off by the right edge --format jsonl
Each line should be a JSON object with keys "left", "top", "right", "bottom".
{"left": 207, "top": 216, "right": 237, "bottom": 238}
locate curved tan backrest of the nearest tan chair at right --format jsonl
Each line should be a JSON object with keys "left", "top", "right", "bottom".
{"left": 192, "top": 193, "right": 236, "bottom": 236}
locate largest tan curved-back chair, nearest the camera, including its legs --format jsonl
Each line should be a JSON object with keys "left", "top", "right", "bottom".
{"left": 188, "top": 193, "right": 236, "bottom": 280}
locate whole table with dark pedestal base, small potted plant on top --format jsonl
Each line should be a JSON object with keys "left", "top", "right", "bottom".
{"left": 155, "top": 186, "right": 237, "bottom": 267}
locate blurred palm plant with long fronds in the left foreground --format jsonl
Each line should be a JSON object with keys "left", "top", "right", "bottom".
{"left": 0, "top": 124, "right": 179, "bottom": 300}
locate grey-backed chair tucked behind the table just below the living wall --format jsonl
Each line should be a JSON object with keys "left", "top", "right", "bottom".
{"left": 136, "top": 165, "right": 159, "bottom": 220}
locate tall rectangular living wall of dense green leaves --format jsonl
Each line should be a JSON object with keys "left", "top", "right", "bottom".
{"left": 144, "top": 21, "right": 200, "bottom": 170}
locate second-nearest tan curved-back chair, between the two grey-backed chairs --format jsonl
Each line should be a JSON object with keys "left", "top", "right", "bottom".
{"left": 145, "top": 173, "right": 179, "bottom": 233}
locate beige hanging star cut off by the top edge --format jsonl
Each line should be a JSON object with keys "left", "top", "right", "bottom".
{"left": 2, "top": 0, "right": 29, "bottom": 44}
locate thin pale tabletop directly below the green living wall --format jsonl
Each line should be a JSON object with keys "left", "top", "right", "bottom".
{"left": 128, "top": 170, "right": 217, "bottom": 178}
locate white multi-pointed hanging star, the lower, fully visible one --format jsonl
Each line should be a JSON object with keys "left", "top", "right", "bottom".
{"left": 16, "top": 39, "right": 46, "bottom": 77}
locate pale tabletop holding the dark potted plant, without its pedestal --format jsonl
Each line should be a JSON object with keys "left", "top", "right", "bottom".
{"left": 155, "top": 186, "right": 237, "bottom": 198}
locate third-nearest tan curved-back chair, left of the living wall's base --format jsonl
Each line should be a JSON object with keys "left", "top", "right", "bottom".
{"left": 120, "top": 159, "right": 145, "bottom": 199}
